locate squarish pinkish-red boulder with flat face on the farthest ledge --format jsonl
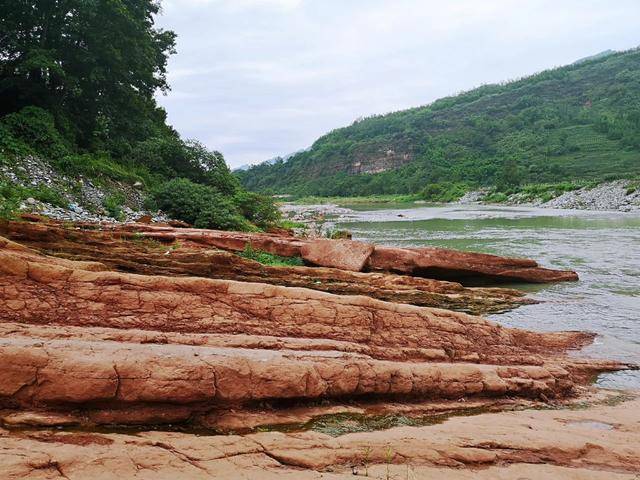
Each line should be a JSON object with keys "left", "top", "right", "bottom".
{"left": 300, "top": 239, "right": 374, "bottom": 272}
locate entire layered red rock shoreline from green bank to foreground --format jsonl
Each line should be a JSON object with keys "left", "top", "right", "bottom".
{"left": 0, "top": 217, "right": 640, "bottom": 480}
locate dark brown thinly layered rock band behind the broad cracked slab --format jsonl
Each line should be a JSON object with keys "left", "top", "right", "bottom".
{"left": 0, "top": 218, "right": 534, "bottom": 314}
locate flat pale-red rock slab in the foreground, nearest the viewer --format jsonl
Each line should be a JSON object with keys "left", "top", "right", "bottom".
{"left": 0, "top": 394, "right": 640, "bottom": 480}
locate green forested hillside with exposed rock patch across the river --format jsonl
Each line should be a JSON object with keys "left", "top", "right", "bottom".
{"left": 237, "top": 49, "right": 640, "bottom": 196}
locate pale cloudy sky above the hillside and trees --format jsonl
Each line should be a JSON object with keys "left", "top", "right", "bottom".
{"left": 156, "top": 0, "right": 640, "bottom": 168}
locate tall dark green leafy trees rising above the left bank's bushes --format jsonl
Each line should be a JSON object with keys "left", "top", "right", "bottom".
{"left": 0, "top": 0, "right": 175, "bottom": 153}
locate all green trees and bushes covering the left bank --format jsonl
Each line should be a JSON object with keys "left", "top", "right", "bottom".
{"left": 0, "top": 0, "right": 279, "bottom": 230}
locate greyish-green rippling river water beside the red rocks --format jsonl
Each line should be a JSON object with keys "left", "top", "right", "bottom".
{"left": 337, "top": 205, "right": 640, "bottom": 389}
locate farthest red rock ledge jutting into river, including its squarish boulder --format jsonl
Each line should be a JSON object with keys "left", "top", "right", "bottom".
{"left": 3, "top": 218, "right": 578, "bottom": 283}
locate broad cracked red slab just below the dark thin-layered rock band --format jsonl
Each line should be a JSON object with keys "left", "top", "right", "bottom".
{"left": 0, "top": 233, "right": 592, "bottom": 363}
